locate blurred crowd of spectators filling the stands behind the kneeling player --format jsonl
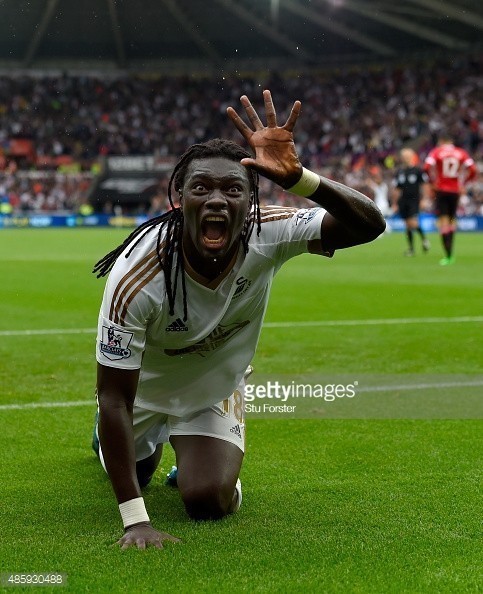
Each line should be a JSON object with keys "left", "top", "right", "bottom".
{"left": 0, "top": 56, "right": 483, "bottom": 214}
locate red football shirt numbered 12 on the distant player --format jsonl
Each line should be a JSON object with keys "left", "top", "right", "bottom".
{"left": 424, "top": 144, "right": 476, "bottom": 194}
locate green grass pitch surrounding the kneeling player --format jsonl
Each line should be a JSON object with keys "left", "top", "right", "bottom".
{"left": 0, "top": 229, "right": 483, "bottom": 593}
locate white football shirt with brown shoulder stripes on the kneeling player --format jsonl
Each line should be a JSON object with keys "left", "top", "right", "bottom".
{"left": 97, "top": 206, "right": 325, "bottom": 416}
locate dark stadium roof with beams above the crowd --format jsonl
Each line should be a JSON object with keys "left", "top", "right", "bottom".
{"left": 0, "top": 0, "right": 483, "bottom": 73}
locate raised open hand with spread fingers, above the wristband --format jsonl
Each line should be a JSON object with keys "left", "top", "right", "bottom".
{"left": 226, "top": 91, "right": 302, "bottom": 188}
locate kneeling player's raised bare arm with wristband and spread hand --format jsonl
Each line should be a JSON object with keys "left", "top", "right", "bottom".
{"left": 227, "top": 91, "right": 386, "bottom": 253}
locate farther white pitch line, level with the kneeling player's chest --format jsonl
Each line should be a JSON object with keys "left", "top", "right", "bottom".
{"left": 0, "top": 316, "right": 483, "bottom": 336}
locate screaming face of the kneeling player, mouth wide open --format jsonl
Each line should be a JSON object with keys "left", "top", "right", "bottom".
{"left": 181, "top": 157, "right": 250, "bottom": 260}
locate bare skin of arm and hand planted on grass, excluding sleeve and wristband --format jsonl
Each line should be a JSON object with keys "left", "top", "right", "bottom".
{"left": 97, "top": 363, "right": 179, "bottom": 549}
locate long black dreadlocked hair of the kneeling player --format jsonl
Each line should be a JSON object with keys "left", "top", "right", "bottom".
{"left": 92, "top": 138, "right": 261, "bottom": 322}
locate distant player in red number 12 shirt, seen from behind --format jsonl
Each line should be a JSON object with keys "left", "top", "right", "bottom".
{"left": 424, "top": 137, "right": 476, "bottom": 266}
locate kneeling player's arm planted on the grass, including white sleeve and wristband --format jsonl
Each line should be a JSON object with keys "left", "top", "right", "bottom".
{"left": 96, "top": 236, "right": 178, "bottom": 549}
